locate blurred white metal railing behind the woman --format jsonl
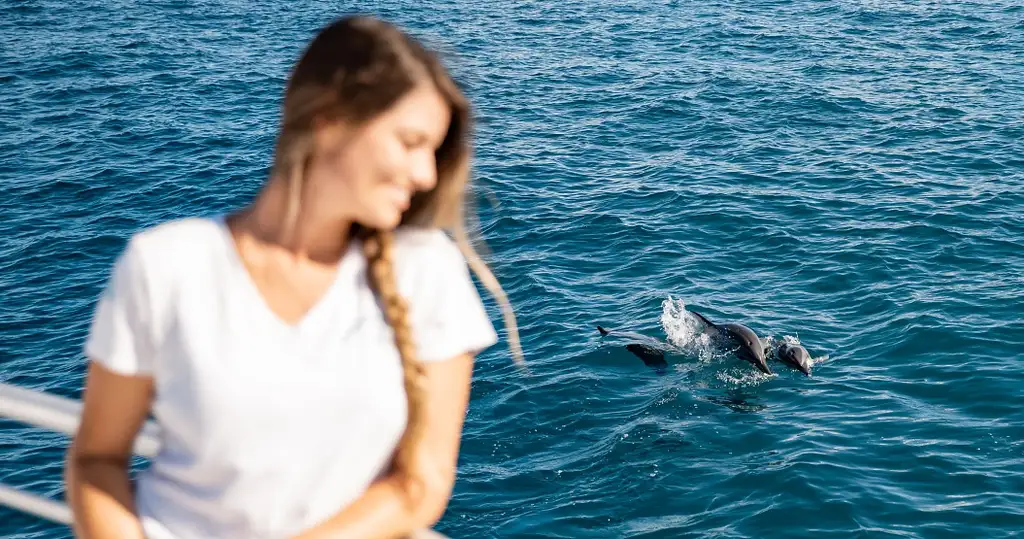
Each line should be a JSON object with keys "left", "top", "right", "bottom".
{"left": 0, "top": 383, "right": 446, "bottom": 539}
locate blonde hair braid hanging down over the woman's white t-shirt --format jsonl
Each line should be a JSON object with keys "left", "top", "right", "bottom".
{"left": 364, "top": 231, "right": 426, "bottom": 499}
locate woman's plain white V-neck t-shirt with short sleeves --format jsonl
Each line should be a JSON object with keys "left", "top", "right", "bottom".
{"left": 85, "top": 216, "right": 498, "bottom": 539}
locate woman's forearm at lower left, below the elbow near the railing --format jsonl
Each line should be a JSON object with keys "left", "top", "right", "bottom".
{"left": 65, "top": 454, "right": 144, "bottom": 539}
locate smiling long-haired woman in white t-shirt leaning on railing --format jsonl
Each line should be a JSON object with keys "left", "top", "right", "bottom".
{"left": 66, "top": 13, "right": 520, "bottom": 539}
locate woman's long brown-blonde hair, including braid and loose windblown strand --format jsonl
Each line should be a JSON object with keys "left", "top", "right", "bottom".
{"left": 271, "top": 16, "right": 523, "bottom": 508}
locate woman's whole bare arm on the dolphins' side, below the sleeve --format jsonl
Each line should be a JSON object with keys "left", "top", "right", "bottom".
{"left": 295, "top": 354, "right": 473, "bottom": 539}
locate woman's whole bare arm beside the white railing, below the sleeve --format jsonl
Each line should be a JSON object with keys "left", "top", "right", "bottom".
{"left": 65, "top": 362, "right": 153, "bottom": 539}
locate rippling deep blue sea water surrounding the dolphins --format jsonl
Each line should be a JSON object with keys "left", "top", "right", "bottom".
{"left": 0, "top": 0, "right": 1024, "bottom": 538}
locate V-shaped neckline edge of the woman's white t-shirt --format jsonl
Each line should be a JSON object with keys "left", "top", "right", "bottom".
{"left": 213, "top": 214, "right": 359, "bottom": 332}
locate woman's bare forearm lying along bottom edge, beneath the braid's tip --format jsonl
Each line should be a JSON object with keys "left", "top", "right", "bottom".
{"left": 295, "top": 474, "right": 447, "bottom": 539}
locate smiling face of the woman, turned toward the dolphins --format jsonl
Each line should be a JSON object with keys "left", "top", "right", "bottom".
{"left": 305, "top": 84, "right": 452, "bottom": 230}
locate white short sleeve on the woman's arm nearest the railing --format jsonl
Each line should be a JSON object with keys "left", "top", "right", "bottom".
{"left": 84, "top": 240, "right": 155, "bottom": 376}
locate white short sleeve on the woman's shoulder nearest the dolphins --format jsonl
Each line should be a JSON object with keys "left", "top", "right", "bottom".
{"left": 410, "top": 231, "right": 498, "bottom": 362}
